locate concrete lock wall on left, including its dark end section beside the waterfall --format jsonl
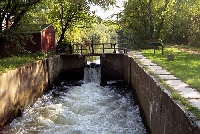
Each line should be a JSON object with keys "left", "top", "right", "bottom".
{"left": 0, "top": 55, "right": 85, "bottom": 130}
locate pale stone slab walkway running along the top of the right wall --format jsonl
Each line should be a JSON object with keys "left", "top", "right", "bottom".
{"left": 128, "top": 51, "right": 200, "bottom": 110}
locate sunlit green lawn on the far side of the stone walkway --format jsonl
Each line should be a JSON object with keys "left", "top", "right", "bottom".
{"left": 142, "top": 46, "right": 200, "bottom": 91}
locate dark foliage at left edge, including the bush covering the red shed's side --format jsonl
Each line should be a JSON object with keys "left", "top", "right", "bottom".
{"left": 0, "top": 0, "right": 41, "bottom": 57}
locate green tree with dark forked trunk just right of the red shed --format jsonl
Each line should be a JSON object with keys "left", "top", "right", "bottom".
{"left": 25, "top": 0, "right": 115, "bottom": 44}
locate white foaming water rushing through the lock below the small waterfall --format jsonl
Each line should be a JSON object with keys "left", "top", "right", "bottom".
{"left": 3, "top": 64, "right": 147, "bottom": 134}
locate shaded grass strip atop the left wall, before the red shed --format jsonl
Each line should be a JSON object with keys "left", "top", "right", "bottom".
{"left": 0, "top": 53, "right": 52, "bottom": 74}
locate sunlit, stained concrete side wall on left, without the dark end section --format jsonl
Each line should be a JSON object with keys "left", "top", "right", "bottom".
{"left": 0, "top": 56, "right": 62, "bottom": 129}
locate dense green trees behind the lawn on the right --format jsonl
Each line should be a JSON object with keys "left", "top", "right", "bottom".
{"left": 120, "top": 0, "right": 200, "bottom": 48}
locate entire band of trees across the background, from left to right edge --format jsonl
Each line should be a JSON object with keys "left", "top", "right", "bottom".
{"left": 0, "top": 0, "right": 200, "bottom": 51}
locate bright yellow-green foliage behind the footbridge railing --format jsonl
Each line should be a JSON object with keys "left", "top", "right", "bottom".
{"left": 65, "top": 19, "right": 119, "bottom": 53}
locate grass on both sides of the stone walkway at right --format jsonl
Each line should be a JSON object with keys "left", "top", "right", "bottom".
{"left": 142, "top": 46, "right": 200, "bottom": 119}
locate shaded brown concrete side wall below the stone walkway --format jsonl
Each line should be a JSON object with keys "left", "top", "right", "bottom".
{"left": 124, "top": 55, "right": 200, "bottom": 134}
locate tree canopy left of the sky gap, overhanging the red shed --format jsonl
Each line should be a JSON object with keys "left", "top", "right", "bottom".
{"left": 0, "top": 0, "right": 115, "bottom": 56}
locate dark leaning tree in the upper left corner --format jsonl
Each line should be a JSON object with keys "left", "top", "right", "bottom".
{"left": 0, "top": 0, "right": 41, "bottom": 56}
